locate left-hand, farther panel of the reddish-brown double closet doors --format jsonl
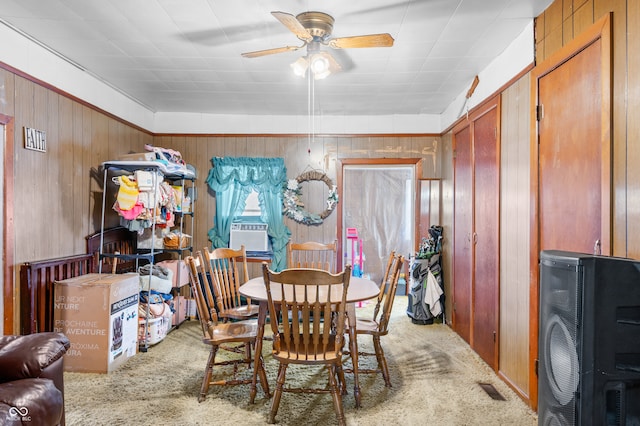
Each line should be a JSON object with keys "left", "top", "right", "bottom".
{"left": 452, "top": 125, "right": 473, "bottom": 343}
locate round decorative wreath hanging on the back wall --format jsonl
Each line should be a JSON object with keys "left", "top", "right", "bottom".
{"left": 282, "top": 171, "right": 338, "bottom": 225}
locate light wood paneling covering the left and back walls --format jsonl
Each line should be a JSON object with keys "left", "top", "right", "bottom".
{"left": 0, "top": 68, "right": 441, "bottom": 332}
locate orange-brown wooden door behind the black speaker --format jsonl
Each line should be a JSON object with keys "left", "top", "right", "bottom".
{"left": 538, "top": 40, "right": 609, "bottom": 253}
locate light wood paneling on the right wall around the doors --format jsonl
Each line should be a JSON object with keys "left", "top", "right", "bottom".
{"left": 441, "top": 0, "right": 640, "bottom": 408}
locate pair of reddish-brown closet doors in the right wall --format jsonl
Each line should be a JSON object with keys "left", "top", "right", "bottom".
{"left": 453, "top": 97, "right": 500, "bottom": 370}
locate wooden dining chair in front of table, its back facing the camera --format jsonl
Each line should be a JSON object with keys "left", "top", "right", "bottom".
{"left": 262, "top": 263, "right": 351, "bottom": 425}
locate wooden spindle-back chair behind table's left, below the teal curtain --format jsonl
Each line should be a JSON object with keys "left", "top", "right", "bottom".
{"left": 204, "top": 246, "right": 259, "bottom": 321}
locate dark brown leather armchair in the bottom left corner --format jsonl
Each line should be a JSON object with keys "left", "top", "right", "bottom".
{"left": 0, "top": 332, "right": 70, "bottom": 425}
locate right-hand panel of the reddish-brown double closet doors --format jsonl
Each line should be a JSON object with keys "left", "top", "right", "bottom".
{"left": 471, "top": 104, "right": 500, "bottom": 369}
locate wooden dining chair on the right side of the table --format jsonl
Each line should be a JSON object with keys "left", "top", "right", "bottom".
{"left": 345, "top": 251, "right": 404, "bottom": 387}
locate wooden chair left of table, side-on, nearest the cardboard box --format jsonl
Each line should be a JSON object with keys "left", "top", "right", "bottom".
{"left": 185, "top": 252, "right": 271, "bottom": 402}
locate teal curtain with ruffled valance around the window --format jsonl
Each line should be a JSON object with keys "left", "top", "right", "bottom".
{"left": 207, "top": 157, "right": 291, "bottom": 271}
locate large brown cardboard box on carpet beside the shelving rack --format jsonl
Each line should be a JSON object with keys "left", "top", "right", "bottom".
{"left": 53, "top": 273, "right": 140, "bottom": 373}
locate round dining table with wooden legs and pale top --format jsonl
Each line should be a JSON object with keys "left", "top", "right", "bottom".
{"left": 239, "top": 277, "right": 380, "bottom": 408}
